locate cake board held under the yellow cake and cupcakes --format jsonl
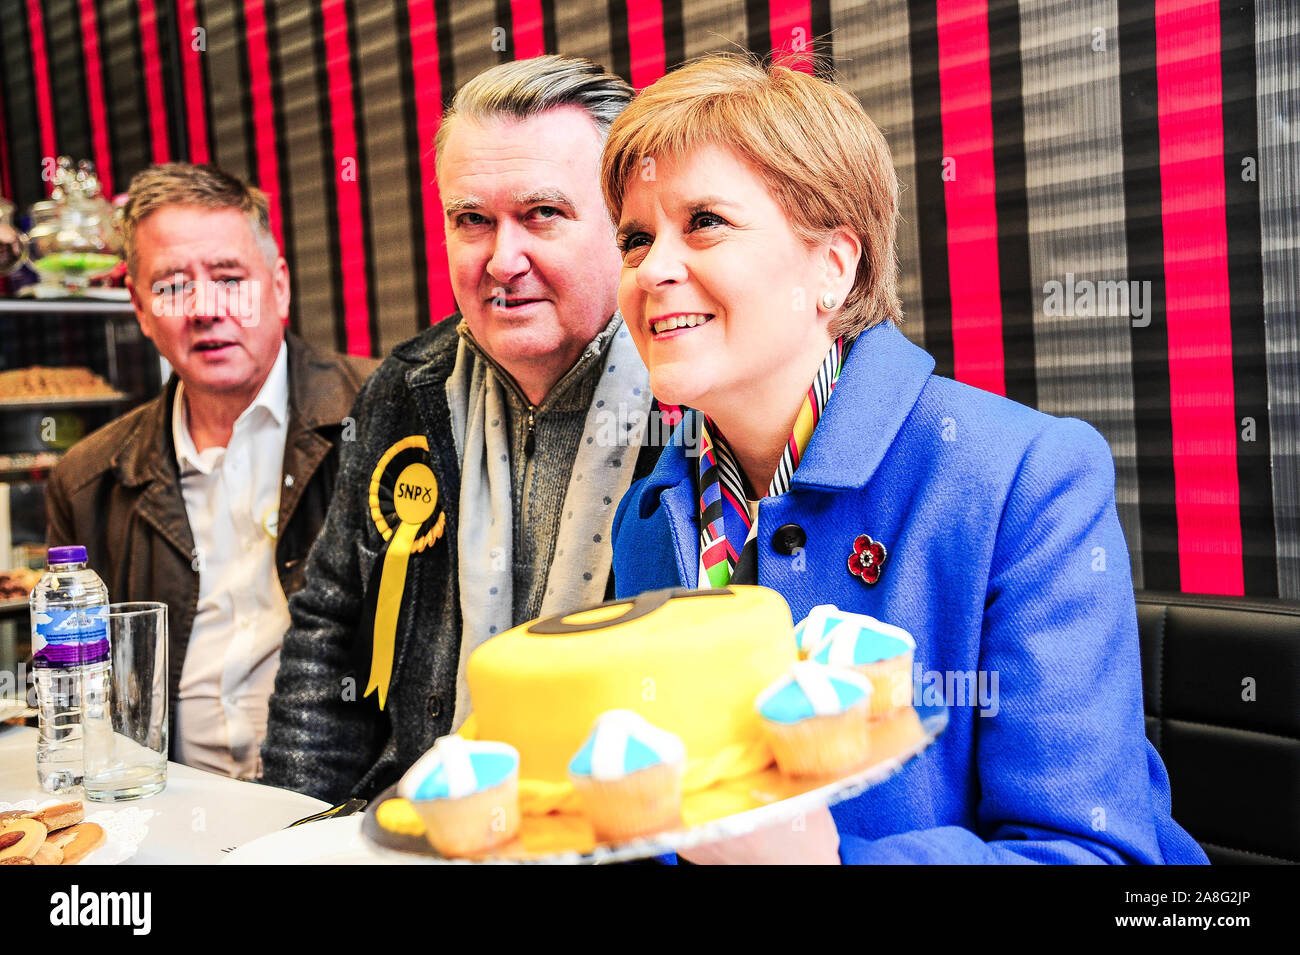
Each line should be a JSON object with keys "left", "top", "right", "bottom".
{"left": 361, "top": 706, "right": 948, "bottom": 864}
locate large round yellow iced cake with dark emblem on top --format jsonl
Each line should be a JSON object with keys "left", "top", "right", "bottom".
{"left": 462, "top": 586, "right": 797, "bottom": 812}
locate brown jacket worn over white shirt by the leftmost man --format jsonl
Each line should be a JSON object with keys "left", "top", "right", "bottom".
{"left": 46, "top": 333, "right": 378, "bottom": 746}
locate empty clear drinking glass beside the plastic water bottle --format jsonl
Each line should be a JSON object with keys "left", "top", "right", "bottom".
{"left": 82, "top": 602, "right": 168, "bottom": 803}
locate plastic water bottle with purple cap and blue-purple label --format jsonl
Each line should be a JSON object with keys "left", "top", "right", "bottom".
{"left": 31, "top": 547, "right": 109, "bottom": 793}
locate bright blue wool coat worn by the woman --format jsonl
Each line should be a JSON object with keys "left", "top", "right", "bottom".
{"left": 614, "top": 324, "right": 1206, "bottom": 863}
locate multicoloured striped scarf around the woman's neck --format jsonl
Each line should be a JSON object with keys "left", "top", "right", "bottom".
{"left": 697, "top": 338, "right": 848, "bottom": 587}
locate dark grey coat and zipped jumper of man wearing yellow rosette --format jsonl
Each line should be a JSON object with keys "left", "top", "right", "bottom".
{"left": 261, "top": 316, "right": 659, "bottom": 802}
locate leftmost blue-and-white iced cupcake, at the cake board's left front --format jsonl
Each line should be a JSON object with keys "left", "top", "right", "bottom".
{"left": 398, "top": 735, "right": 519, "bottom": 856}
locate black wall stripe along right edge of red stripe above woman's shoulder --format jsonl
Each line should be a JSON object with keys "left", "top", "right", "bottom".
{"left": 988, "top": 0, "right": 1039, "bottom": 408}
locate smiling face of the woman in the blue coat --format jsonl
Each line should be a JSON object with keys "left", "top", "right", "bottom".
{"left": 619, "top": 146, "right": 852, "bottom": 418}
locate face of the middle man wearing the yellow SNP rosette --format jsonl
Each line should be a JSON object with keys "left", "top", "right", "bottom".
{"left": 438, "top": 107, "right": 619, "bottom": 403}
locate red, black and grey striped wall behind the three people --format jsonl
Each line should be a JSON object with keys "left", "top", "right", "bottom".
{"left": 0, "top": 0, "right": 1300, "bottom": 599}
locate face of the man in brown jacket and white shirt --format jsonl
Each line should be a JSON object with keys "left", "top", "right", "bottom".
{"left": 127, "top": 205, "right": 289, "bottom": 405}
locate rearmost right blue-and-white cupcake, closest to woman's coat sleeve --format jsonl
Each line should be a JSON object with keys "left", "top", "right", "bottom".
{"left": 809, "top": 613, "right": 917, "bottom": 717}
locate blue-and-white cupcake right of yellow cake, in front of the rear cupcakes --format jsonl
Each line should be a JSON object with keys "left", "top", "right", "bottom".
{"left": 754, "top": 661, "right": 872, "bottom": 776}
